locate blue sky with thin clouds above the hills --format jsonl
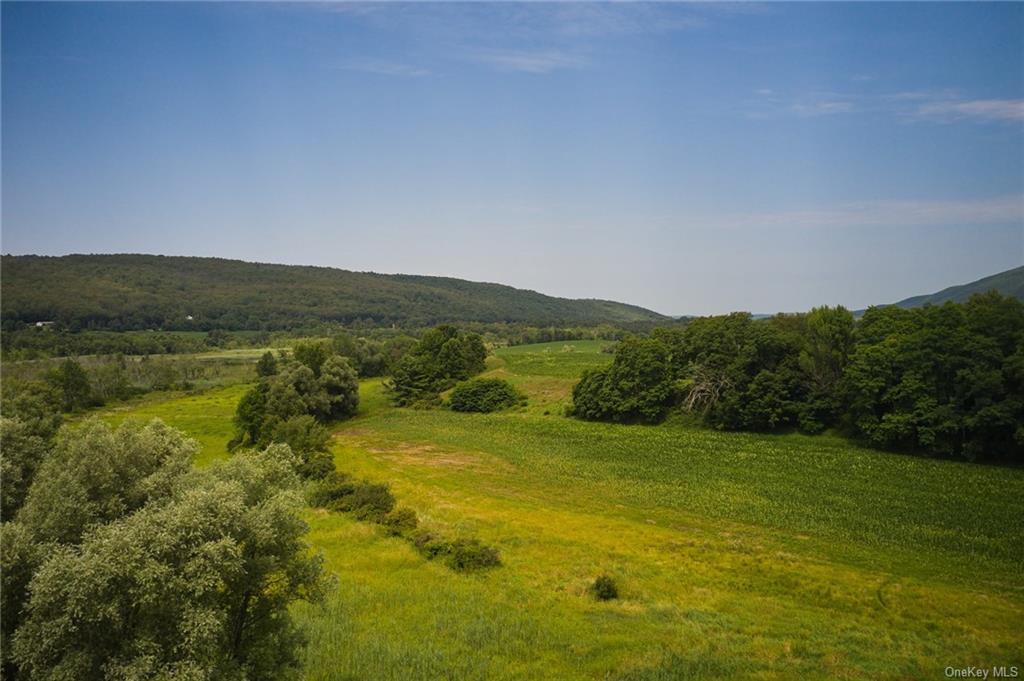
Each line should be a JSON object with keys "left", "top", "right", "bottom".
{"left": 0, "top": 2, "right": 1024, "bottom": 313}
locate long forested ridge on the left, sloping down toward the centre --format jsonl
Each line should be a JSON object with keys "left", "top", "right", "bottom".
{"left": 0, "top": 255, "right": 669, "bottom": 330}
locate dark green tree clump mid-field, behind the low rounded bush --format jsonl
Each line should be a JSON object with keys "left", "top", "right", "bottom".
{"left": 388, "top": 325, "right": 487, "bottom": 407}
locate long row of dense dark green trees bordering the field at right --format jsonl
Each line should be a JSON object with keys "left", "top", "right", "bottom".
{"left": 571, "top": 292, "right": 1024, "bottom": 463}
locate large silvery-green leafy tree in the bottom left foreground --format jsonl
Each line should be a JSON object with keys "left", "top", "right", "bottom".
{"left": 13, "top": 440, "right": 324, "bottom": 681}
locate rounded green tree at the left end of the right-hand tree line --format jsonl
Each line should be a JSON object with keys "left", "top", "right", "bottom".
{"left": 572, "top": 338, "right": 672, "bottom": 422}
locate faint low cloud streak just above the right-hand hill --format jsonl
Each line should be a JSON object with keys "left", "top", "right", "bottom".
{"left": 720, "top": 195, "right": 1024, "bottom": 228}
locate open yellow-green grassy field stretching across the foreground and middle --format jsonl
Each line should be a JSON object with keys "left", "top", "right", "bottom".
{"left": 99, "top": 342, "right": 1024, "bottom": 680}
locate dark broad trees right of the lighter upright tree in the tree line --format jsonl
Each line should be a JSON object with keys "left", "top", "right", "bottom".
{"left": 844, "top": 293, "right": 1024, "bottom": 463}
